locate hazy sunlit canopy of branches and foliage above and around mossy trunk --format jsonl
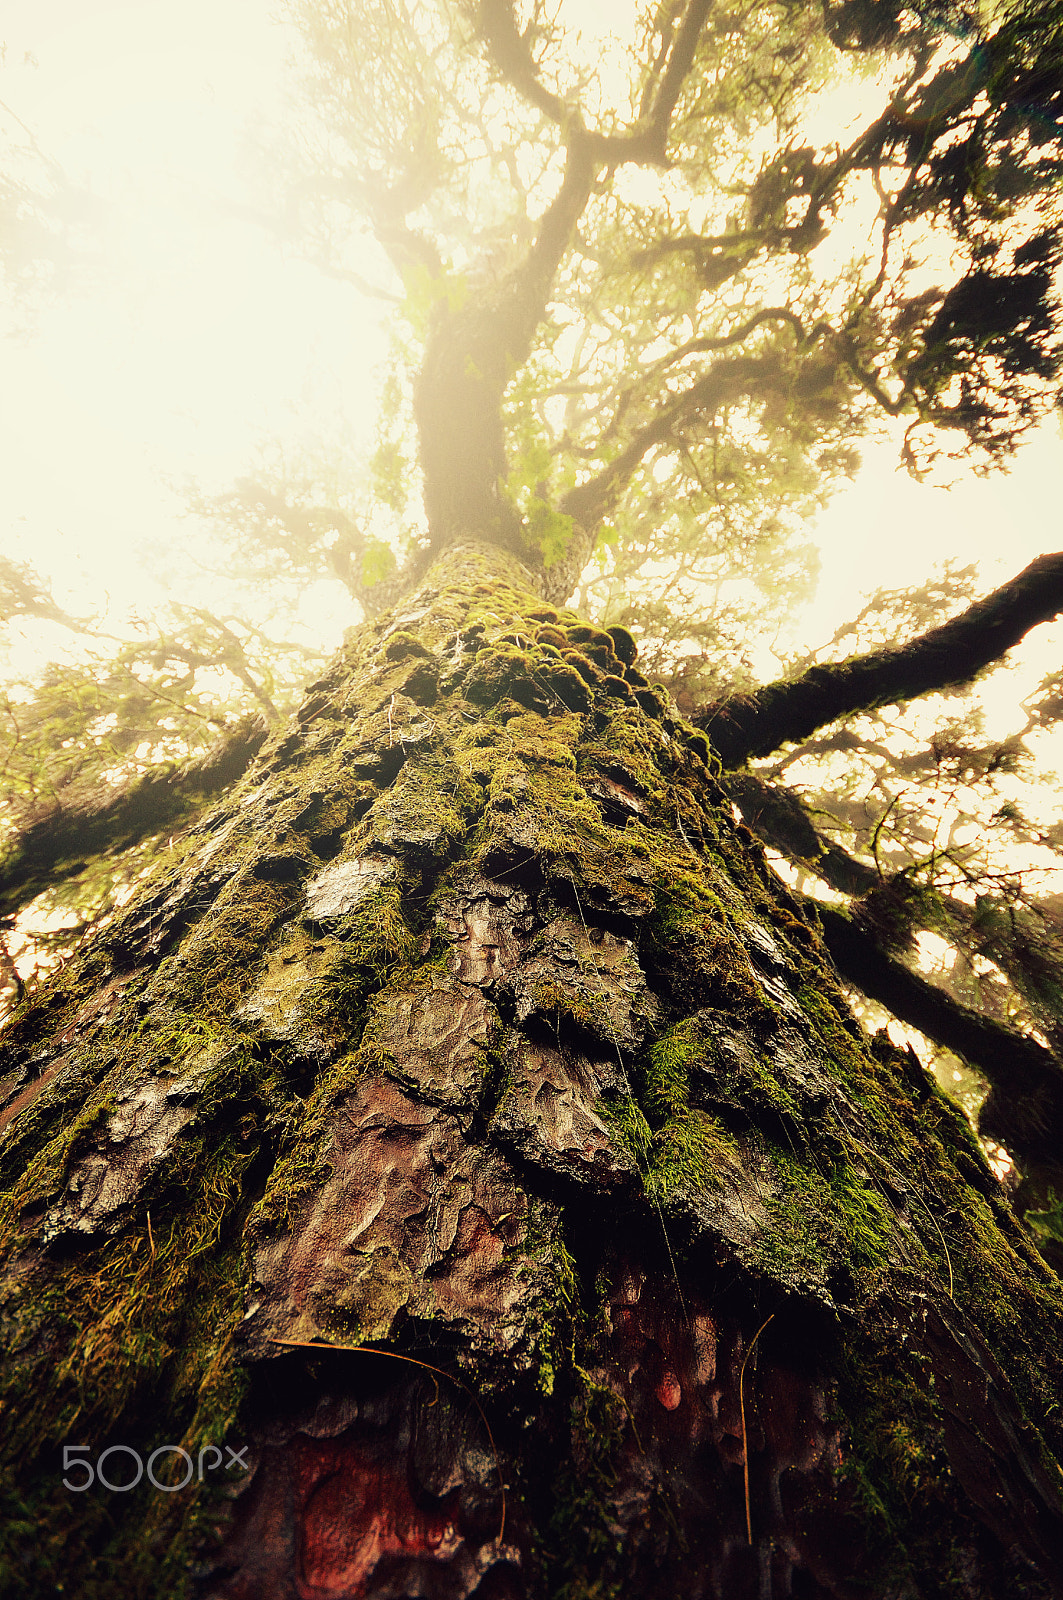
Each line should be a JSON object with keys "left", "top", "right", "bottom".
{"left": 0, "top": 0, "right": 1063, "bottom": 1250}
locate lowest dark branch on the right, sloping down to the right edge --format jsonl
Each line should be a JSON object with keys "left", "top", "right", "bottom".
{"left": 808, "top": 901, "right": 1063, "bottom": 1173}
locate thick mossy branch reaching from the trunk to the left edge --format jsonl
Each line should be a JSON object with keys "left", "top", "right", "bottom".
{"left": 0, "top": 717, "right": 267, "bottom": 920}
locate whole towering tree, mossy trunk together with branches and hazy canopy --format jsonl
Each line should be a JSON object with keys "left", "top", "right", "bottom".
{"left": 5, "top": 0, "right": 1063, "bottom": 1594}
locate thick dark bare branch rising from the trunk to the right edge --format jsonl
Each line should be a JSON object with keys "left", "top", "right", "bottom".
{"left": 693, "top": 552, "right": 1063, "bottom": 766}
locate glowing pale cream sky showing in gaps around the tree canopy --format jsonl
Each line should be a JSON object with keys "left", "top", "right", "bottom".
{"left": 0, "top": 0, "right": 1063, "bottom": 675}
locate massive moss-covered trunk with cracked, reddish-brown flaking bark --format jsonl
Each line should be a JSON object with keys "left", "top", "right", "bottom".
{"left": 0, "top": 546, "right": 1063, "bottom": 1600}
